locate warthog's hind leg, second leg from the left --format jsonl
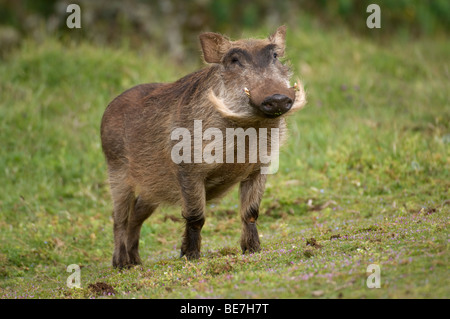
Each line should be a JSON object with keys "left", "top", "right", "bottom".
{"left": 127, "top": 197, "right": 158, "bottom": 265}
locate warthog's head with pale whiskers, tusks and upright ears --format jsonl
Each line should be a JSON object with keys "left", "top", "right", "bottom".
{"left": 200, "top": 26, "right": 306, "bottom": 118}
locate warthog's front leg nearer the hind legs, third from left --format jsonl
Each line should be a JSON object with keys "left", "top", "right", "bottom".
{"left": 179, "top": 174, "right": 205, "bottom": 259}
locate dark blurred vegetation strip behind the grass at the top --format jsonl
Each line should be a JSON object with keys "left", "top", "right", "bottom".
{"left": 0, "top": 0, "right": 450, "bottom": 61}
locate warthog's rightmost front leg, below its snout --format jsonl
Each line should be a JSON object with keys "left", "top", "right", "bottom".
{"left": 239, "top": 172, "right": 266, "bottom": 253}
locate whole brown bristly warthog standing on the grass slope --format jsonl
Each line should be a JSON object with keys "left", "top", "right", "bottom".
{"left": 101, "top": 26, "right": 306, "bottom": 267}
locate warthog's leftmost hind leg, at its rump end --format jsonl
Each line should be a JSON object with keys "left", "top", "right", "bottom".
{"left": 111, "top": 183, "right": 135, "bottom": 268}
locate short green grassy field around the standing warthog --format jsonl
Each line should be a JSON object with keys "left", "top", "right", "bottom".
{"left": 0, "top": 25, "right": 450, "bottom": 298}
